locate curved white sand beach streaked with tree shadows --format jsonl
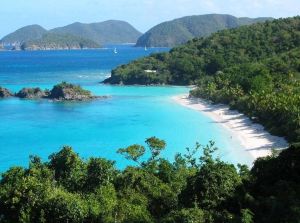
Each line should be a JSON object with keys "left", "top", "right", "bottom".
{"left": 173, "top": 95, "right": 288, "bottom": 159}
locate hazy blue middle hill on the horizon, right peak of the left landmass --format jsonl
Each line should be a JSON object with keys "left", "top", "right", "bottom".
{"left": 50, "top": 20, "right": 141, "bottom": 45}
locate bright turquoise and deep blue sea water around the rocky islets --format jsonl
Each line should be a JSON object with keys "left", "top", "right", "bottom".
{"left": 0, "top": 45, "right": 253, "bottom": 172}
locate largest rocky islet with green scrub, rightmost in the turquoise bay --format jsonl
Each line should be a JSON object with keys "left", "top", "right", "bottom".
{"left": 48, "top": 82, "right": 98, "bottom": 101}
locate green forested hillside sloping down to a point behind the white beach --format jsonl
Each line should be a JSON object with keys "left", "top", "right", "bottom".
{"left": 104, "top": 16, "right": 300, "bottom": 142}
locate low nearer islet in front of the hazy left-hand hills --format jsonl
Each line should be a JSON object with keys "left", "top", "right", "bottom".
{"left": 20, "top": 33, "right": 100, "bottom": 50}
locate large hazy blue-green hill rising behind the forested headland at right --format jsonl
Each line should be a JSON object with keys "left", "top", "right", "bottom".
{"left": 136, "top": 14, "right": 272, "bottom": 47}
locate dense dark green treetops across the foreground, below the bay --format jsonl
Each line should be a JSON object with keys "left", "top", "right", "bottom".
{"left": 0, "top": 137, "right": 300, "bottom": 223}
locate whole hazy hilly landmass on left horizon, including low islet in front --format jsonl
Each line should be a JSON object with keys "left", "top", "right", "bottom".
{"left": 0, "top": 20, "right": 141, "bottom": 50}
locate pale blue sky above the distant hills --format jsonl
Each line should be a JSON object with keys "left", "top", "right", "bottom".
{"left": 0, "top": 0, "right": 300, "bottom": 38}
